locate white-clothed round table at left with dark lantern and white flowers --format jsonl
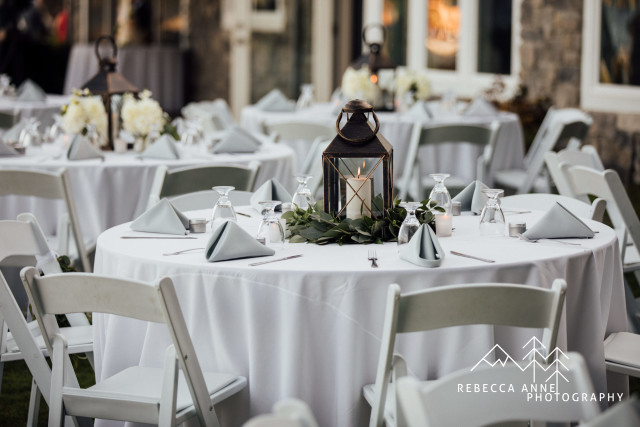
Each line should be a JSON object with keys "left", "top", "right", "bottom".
{"left": 0, "top": 142, "right": 295, "bottom": 246}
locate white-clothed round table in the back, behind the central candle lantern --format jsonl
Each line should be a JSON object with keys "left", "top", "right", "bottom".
{"left": 242, "top": 101, "right": 524, "bottom": 186}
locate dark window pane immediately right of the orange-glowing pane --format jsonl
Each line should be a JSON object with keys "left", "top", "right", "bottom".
{"left": 478, "top": 0, "right": 512, "bottom": 74}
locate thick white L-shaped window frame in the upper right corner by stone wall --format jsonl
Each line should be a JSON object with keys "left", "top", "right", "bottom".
{"left": 580, "top": 0, "right": 640, "bottom": 113}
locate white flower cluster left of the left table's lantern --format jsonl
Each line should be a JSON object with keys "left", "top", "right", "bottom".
{"left": 61, "top": 89, "right": 107, "bottom": 138}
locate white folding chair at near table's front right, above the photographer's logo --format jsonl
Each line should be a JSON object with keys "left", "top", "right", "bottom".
{"left": 363, "top": 279, "right": 567, "bottom": 427}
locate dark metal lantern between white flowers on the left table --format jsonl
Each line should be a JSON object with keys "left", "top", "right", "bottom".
{"left": 82, "top": 36, "right": 138, "bottom": 150}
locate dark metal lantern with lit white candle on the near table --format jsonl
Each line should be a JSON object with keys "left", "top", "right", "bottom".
{"left": 322, "top": 99, "right": 393, "bottom": 219}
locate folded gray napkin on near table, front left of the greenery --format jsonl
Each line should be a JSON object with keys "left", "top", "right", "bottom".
{"left": 204, "top": 221, "right": 276, "bottom": 262}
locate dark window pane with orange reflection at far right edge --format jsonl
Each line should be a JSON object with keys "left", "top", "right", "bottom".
{"left": 600, "top": 1, "right": 640, "bottom": 86}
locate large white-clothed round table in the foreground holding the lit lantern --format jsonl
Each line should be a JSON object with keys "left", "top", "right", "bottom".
{"left": 93, "top": 207, "right": 626, "bottom": 426}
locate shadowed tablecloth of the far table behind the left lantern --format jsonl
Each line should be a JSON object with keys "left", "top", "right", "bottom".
{"left": 64, "top": 44, "right": 185, "bottom": 114}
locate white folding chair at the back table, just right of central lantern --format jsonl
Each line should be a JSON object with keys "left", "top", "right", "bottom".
{"left": 398, "top": 120, "right": 500, "bottom": 200}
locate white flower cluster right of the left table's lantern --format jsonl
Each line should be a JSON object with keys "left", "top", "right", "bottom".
{"left": 120, "top": 89, "right": 165, "bottom": 137}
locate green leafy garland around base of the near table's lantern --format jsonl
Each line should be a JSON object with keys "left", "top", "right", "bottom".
{"left": 282, "top": 199, "right": 442, "bottom": 245}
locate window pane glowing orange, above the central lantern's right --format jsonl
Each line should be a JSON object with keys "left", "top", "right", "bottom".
{"left": 426, "top": 0, "right": 460, "bottom": 70}
